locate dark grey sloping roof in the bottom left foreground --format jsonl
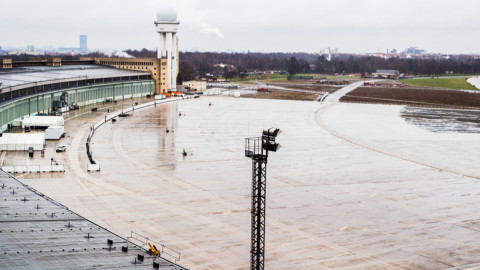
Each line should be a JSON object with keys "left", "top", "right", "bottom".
{"left": 0, "top": 170, "right": 185, "bottom": 270}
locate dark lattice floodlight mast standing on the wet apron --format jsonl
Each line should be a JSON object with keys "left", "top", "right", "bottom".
{"left": 245, "top": 128, "right": 280, "bottom": 270}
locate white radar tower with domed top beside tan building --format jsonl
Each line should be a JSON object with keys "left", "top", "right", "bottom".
{"left": 155, "top": 6, "right": 180, "bottom": 91}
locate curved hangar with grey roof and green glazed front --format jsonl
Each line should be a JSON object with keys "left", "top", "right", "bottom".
{"left": 0, "top": 65, "right": 155, "bottom": 132}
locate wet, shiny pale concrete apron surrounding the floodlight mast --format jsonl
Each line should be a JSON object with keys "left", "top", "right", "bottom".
{"left": 8, "top": 97, "right": 480, "bottom": 269}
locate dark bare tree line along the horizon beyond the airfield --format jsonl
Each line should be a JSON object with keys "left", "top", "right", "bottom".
{"left": 127, "top": 49, "right": 480, "bottom": 79}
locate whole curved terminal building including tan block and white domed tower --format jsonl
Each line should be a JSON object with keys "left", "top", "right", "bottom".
{"left": 0, "top": 8, "right": 179, "bottom": 133}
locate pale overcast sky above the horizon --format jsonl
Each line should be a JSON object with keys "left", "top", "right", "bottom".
{"left": 0, "top": 0, "right": 480, "bottom": 54}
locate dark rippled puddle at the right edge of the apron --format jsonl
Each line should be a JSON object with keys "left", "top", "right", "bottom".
{"left": 400, "top": 107, "right": 480, "bottom": 133}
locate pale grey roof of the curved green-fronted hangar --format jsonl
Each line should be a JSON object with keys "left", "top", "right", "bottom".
{"left": 0, "top": 65, "right": 150, "bottom": 89}
